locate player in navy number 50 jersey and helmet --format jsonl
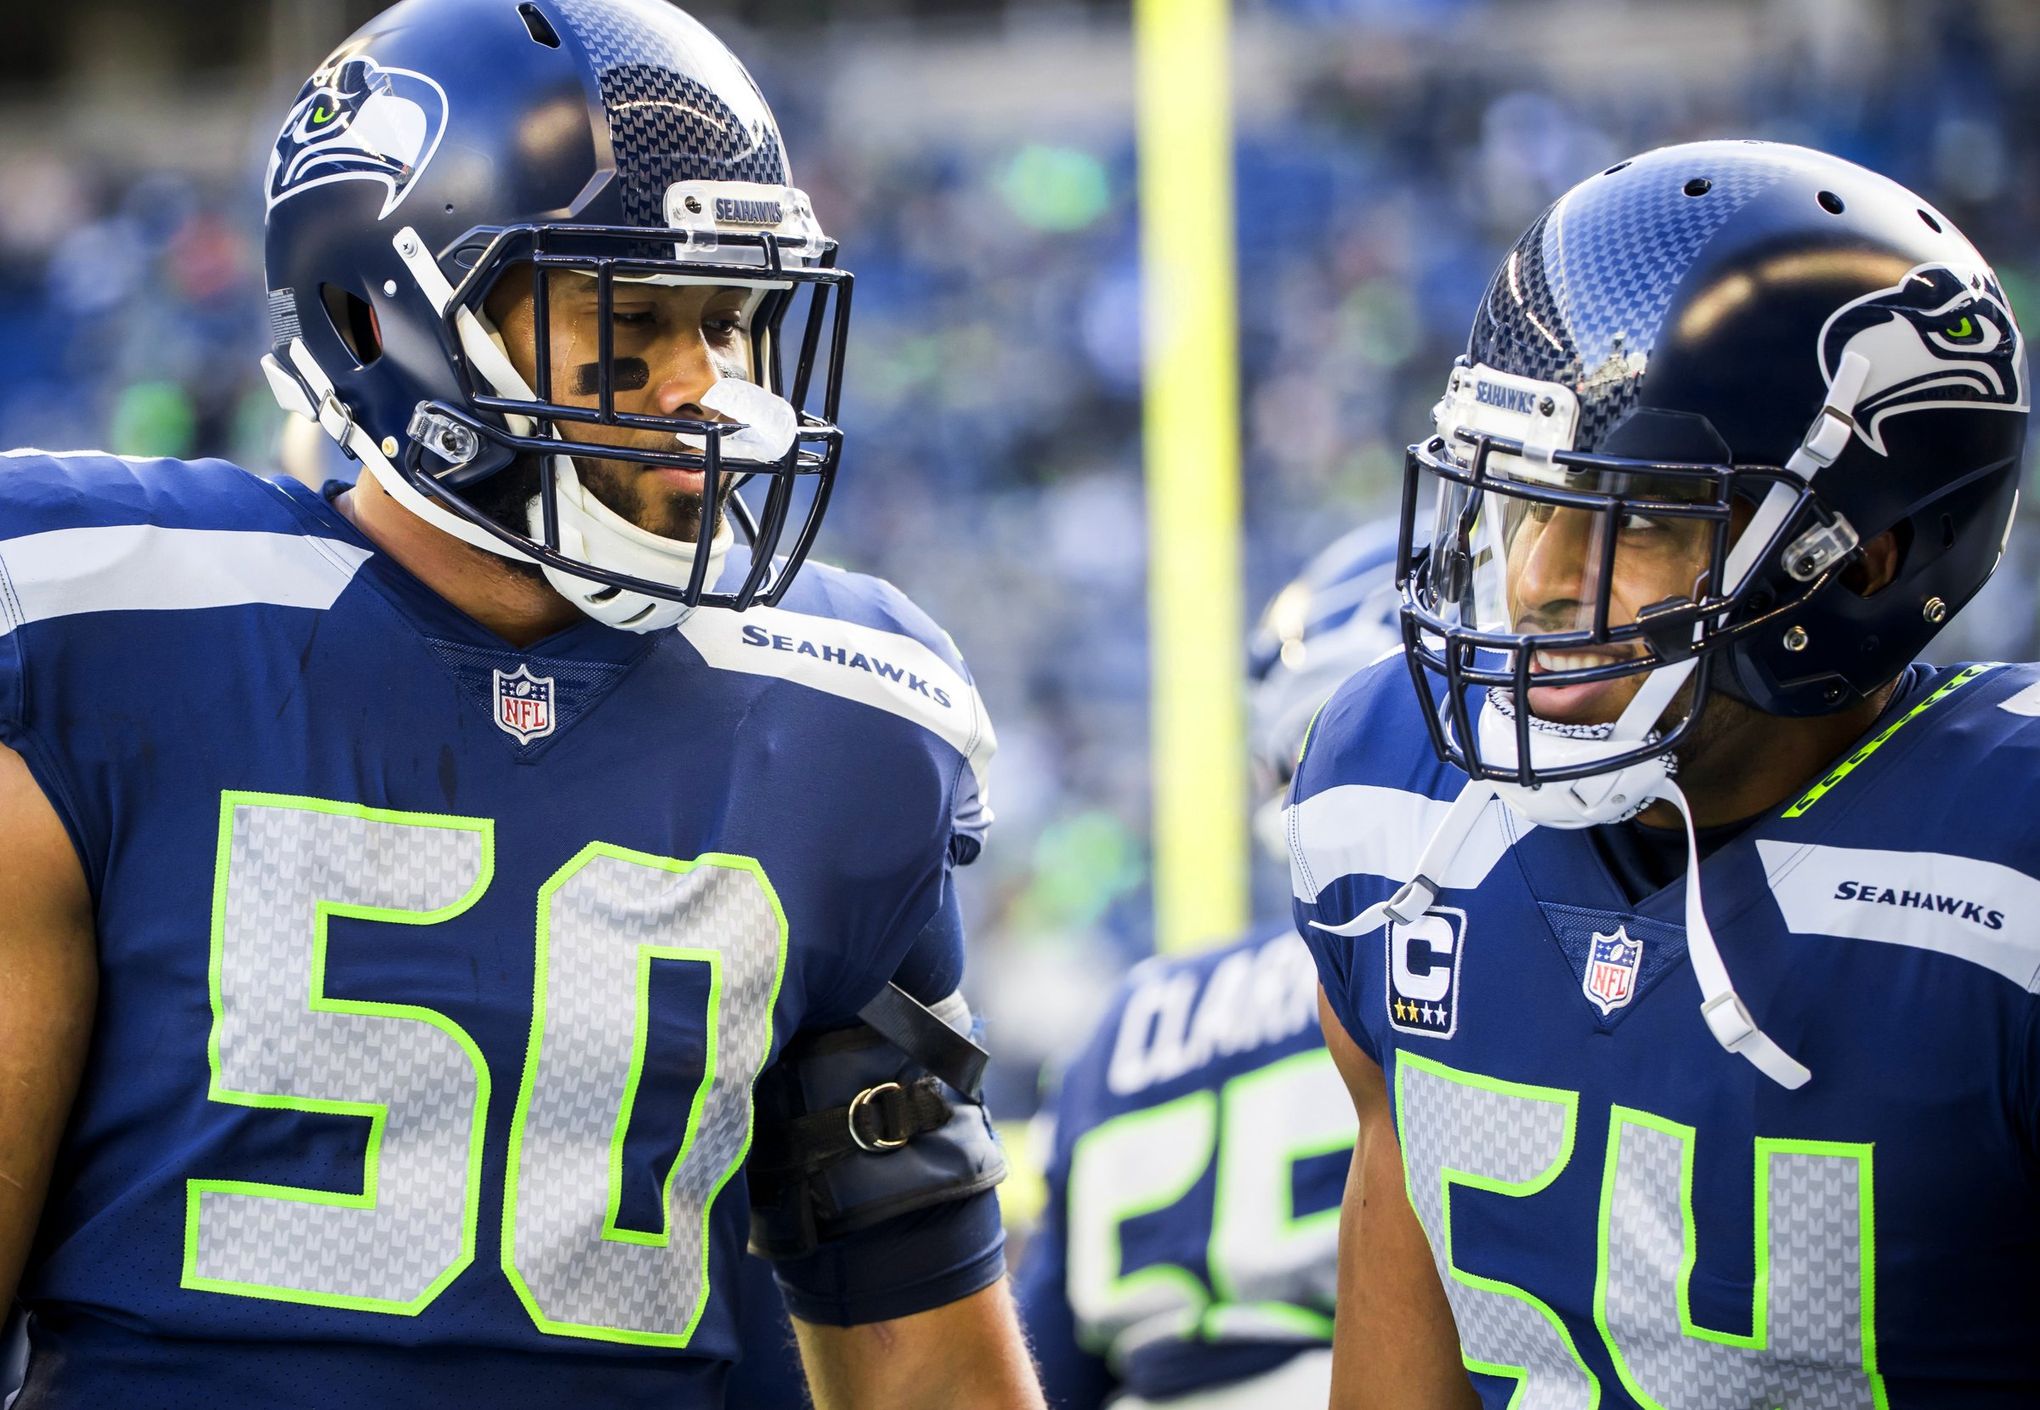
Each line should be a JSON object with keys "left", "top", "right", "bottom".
{"left": 0, "top": 0, "right": 1040, "bottom": 1410}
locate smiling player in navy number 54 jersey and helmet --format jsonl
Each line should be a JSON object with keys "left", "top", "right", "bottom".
{"left": 1289, "top": 143, "right": 2040, "bottom": 1410}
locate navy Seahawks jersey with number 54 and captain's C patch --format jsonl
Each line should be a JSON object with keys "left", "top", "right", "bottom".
{"left": 1289, "top": 663, "right": 2040, "bottom": 1410}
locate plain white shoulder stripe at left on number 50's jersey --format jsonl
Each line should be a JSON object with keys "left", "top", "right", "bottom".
{"left": 0, "top": 524, "right": 369, "bottom": 635}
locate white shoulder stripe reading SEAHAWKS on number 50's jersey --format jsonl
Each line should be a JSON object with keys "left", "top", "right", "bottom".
{"left": 679, "top": 608, "right": 998, "bottom": 799}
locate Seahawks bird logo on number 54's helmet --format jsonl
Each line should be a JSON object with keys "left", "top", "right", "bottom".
{"left": 1820, "top": 265, "right": 2026, "bottom": 455}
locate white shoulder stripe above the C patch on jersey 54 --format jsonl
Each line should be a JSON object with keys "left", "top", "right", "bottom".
{"left": 1285, "top": 784, "right": 1536, "bottom": 902}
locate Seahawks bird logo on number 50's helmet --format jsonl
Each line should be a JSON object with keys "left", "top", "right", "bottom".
{"left": 269, "top": 55, "right": 447, "bottom": 218}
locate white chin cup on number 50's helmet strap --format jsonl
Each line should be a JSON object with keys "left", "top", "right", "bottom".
{"left": 526, "top": 455, "right": 736, "bottom": 633}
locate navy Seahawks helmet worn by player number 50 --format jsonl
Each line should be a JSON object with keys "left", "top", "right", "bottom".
{"left": 263, "top": 0, "right": 851, "bottom": 631}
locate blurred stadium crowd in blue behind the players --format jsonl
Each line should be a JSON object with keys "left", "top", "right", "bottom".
{"left": 0, "top": 0, "right": 2040, "bottom": 1114}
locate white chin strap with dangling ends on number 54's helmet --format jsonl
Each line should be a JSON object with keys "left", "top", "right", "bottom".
{"left": 1312, "top": 353, "right": 1871, "bottom": 1090}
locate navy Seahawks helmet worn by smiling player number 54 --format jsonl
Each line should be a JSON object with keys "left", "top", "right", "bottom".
{"left": 1397, "top": 141, "right": 2030, "bottom": 787}
